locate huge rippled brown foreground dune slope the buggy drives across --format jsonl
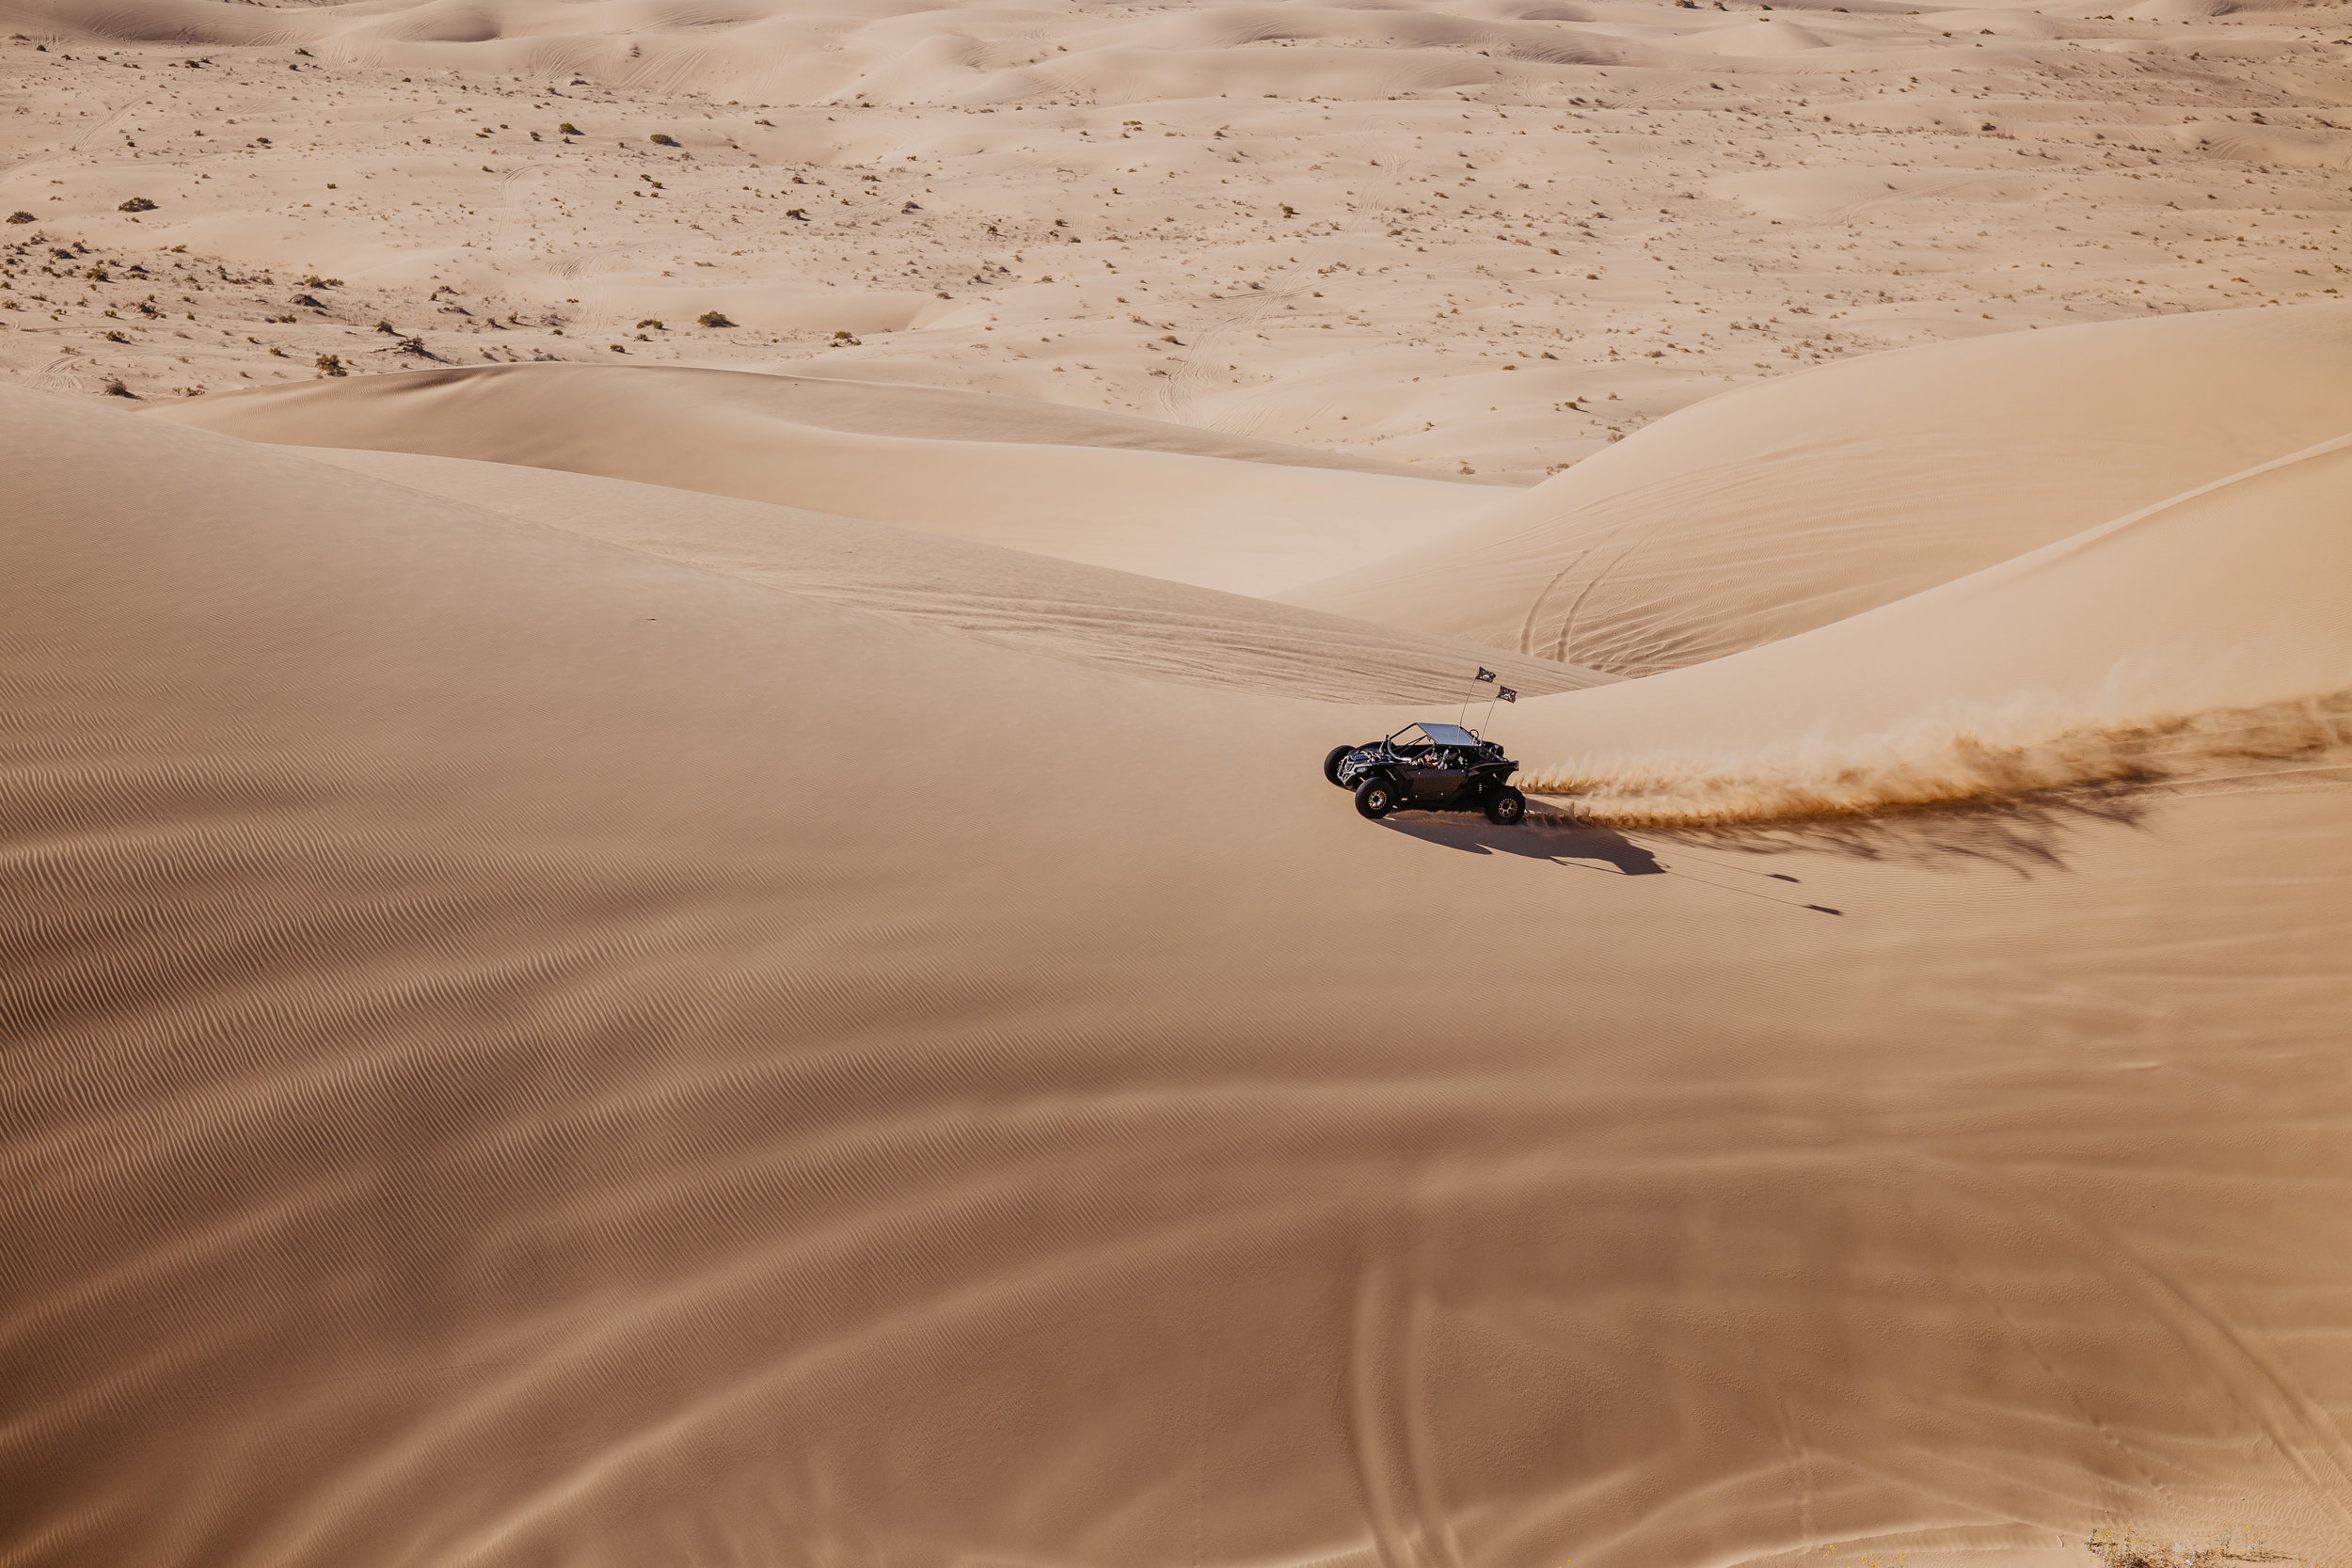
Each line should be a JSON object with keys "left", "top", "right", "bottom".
{"left": 0, "top": 390, "right": 2352, "bottom": 1568}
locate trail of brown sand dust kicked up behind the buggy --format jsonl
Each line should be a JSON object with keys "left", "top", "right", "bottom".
{"left": 1518, "top": 687, "right": 2352, "bottom": 828}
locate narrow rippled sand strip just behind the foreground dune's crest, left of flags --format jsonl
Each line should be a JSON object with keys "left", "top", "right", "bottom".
{"left": 309, "top": 449, "right": 1618, "bottom": 705}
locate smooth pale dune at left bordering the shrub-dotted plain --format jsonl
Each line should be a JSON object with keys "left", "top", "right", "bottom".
{"left": 155, "top": 364, "right": 1494, "bottom": 593}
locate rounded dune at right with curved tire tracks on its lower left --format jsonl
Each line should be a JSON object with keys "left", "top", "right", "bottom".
{"left": 1284, "top": 303, "right": 2352, "bottom": 674}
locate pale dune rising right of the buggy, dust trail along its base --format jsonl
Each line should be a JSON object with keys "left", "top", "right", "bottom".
{"left": 1519, "top": 435, "right": 2352, "bottom": 820}
